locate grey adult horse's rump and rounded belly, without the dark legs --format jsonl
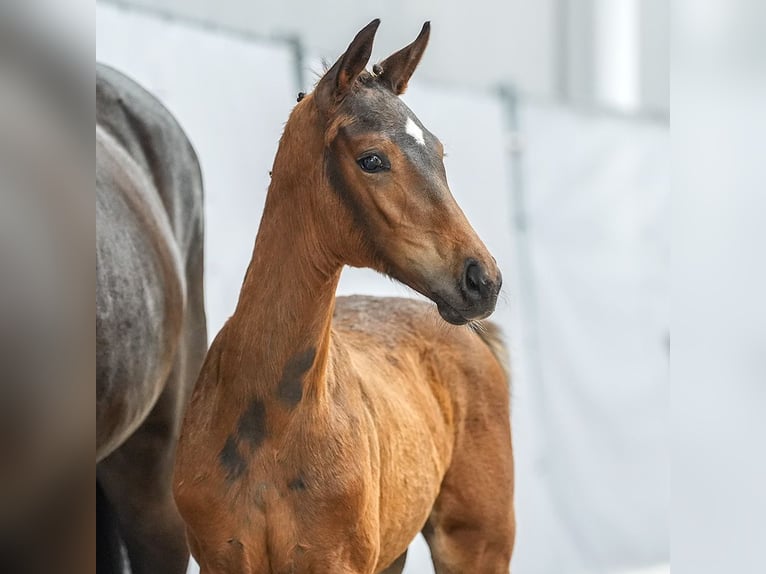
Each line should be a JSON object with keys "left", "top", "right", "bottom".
{"left": 96, "top": 67, "right": 204, "bottom": 458}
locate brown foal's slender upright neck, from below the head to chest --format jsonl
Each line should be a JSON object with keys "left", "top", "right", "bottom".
{"left": 226, "top": 155, "right": 342, "bottom": 408}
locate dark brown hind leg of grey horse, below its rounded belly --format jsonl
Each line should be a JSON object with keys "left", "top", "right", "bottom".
{"left": 96, "top": 244, "right": 207, "bottom": 574}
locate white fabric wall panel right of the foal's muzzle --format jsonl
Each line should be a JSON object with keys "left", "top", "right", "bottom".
{"left": 516, "top": 101, "right": 669, "bottom": 573}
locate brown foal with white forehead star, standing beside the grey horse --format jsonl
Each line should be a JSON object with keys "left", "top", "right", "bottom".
{"left": 174, "top": 20, "right": 515, "bottom": 574}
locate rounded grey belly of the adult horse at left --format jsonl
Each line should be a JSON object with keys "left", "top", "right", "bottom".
{"left": 96, "top": 145, "right": 184, "bottom": 459}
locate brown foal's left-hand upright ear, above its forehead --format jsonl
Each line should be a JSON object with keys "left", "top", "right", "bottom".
{"left": 316, "top": 18, "right": 380, "bottom": 108}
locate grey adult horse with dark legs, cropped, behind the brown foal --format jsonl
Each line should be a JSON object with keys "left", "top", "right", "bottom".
{"left": 96, "top": 67, "right": 207, "bottom": 574}
